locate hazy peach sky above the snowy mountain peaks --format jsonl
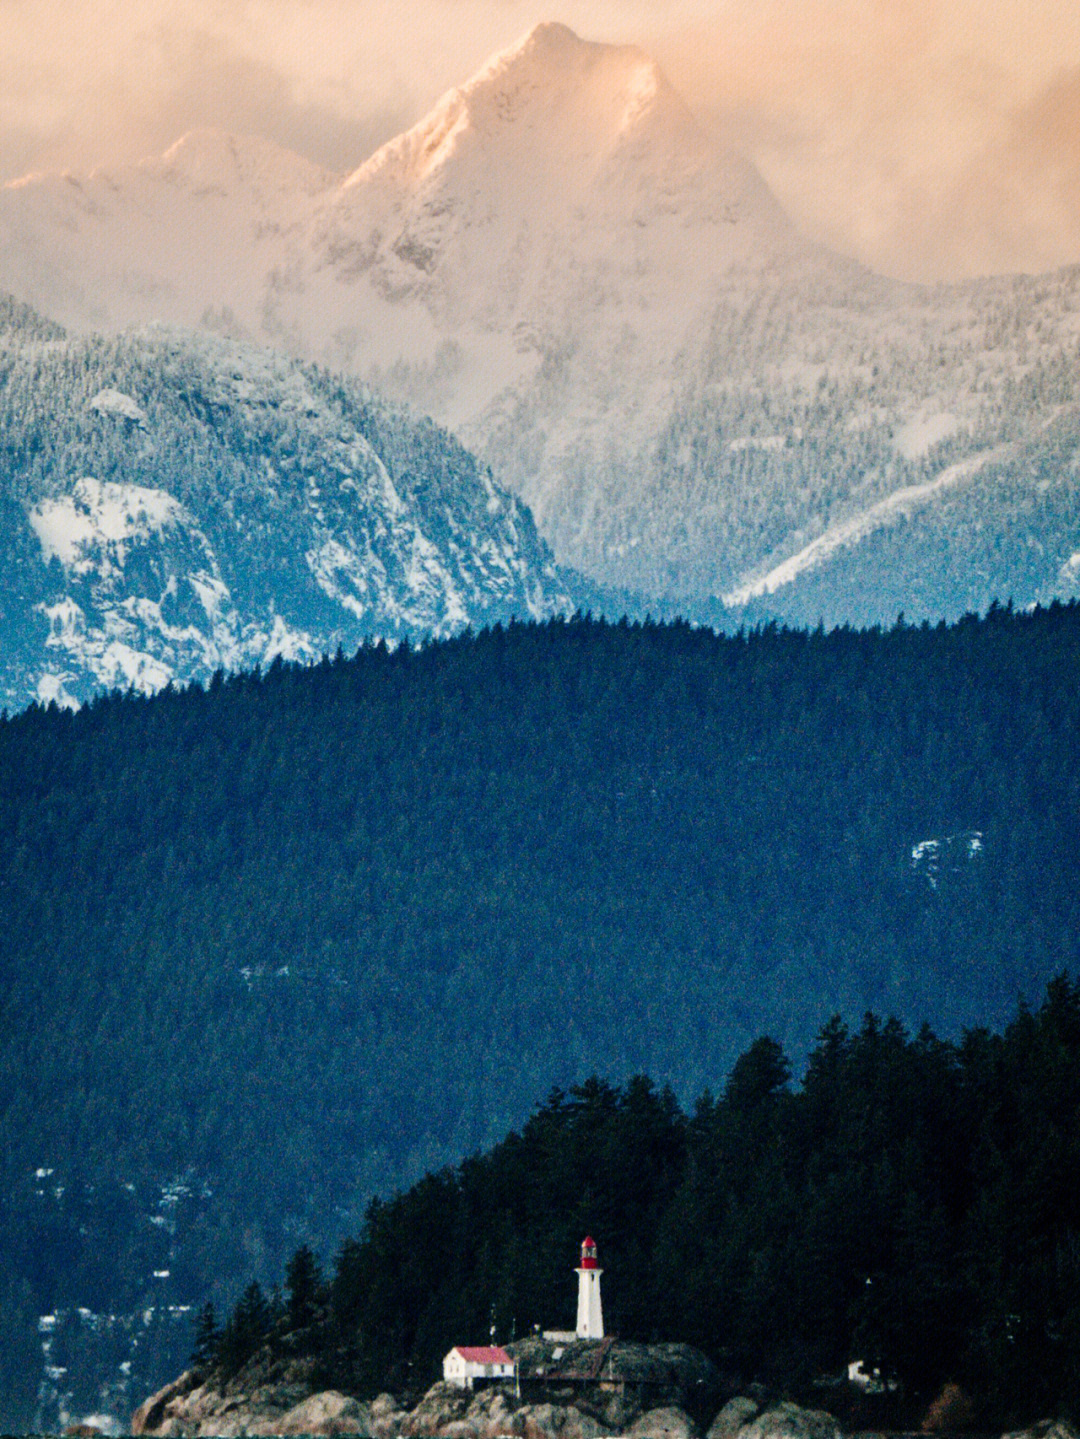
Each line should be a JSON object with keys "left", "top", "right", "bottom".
{"left": 0, "top": 0, "right": 1080, "bottom": 278}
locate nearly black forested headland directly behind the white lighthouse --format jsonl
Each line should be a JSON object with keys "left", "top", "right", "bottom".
{"left": 208, "top": 977, "right": 1080, "bottom": 1427}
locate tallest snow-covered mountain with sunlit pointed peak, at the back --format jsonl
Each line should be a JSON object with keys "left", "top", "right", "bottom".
{"left": 0, "top": 24, "right": 1080, "bottom": 620}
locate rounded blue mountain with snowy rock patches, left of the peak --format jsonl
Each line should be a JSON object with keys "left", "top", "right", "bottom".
{"left": 0, "top": 302, "right": 572, "bottom": 708}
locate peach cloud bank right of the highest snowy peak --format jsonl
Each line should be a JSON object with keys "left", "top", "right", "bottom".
{"left": 647, "top": 0, "right": 1080, "bottom": 279}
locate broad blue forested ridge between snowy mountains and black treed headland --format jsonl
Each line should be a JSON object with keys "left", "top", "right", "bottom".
{"left": 0, "top": 606, "right": 1080, "bottom": 1423}
